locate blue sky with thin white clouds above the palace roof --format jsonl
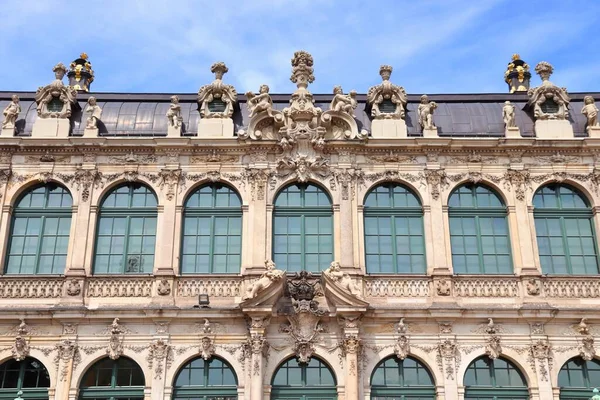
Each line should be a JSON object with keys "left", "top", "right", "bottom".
{"left": 0, "top": 0, "right": 600, "bottom": 94}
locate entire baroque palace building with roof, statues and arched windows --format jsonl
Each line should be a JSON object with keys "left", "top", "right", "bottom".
{"left": 0, "top": 51, "right": 600, "bottom": 400}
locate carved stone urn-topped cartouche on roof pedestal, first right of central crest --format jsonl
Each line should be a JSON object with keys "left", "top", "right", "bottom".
{"left": 367, "top": 65, "right": 407, "bottom": 119}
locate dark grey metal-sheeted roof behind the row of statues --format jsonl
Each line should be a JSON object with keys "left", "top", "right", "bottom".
{"left": 0, "top": 92, "right": 600, "bottom": 137}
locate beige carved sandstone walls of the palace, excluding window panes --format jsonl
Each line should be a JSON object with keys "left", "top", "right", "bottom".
{"left": 0, "top": 52, "right": 600, "bottom": 400}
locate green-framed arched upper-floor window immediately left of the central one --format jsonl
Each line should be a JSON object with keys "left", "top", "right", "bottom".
{"left": 181, "top": 184, "right": 242, "bottom": 274}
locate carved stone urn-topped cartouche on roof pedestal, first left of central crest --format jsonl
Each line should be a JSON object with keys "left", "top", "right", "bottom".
{"left": 198, "top": 62, "right": 237, "bottom": 118}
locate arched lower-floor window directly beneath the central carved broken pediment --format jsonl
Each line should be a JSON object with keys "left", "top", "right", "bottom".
{"left": 271, "top": 357, "right": 337, "bottom": 400}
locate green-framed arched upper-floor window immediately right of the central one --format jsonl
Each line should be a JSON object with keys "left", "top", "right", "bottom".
{"left": 364, "top": 183, "right": 427, "bottom": 274}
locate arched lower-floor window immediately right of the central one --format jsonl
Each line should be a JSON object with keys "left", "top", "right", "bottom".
{"left": 371, "top": 356, "right": 435, "bottom": 400}
